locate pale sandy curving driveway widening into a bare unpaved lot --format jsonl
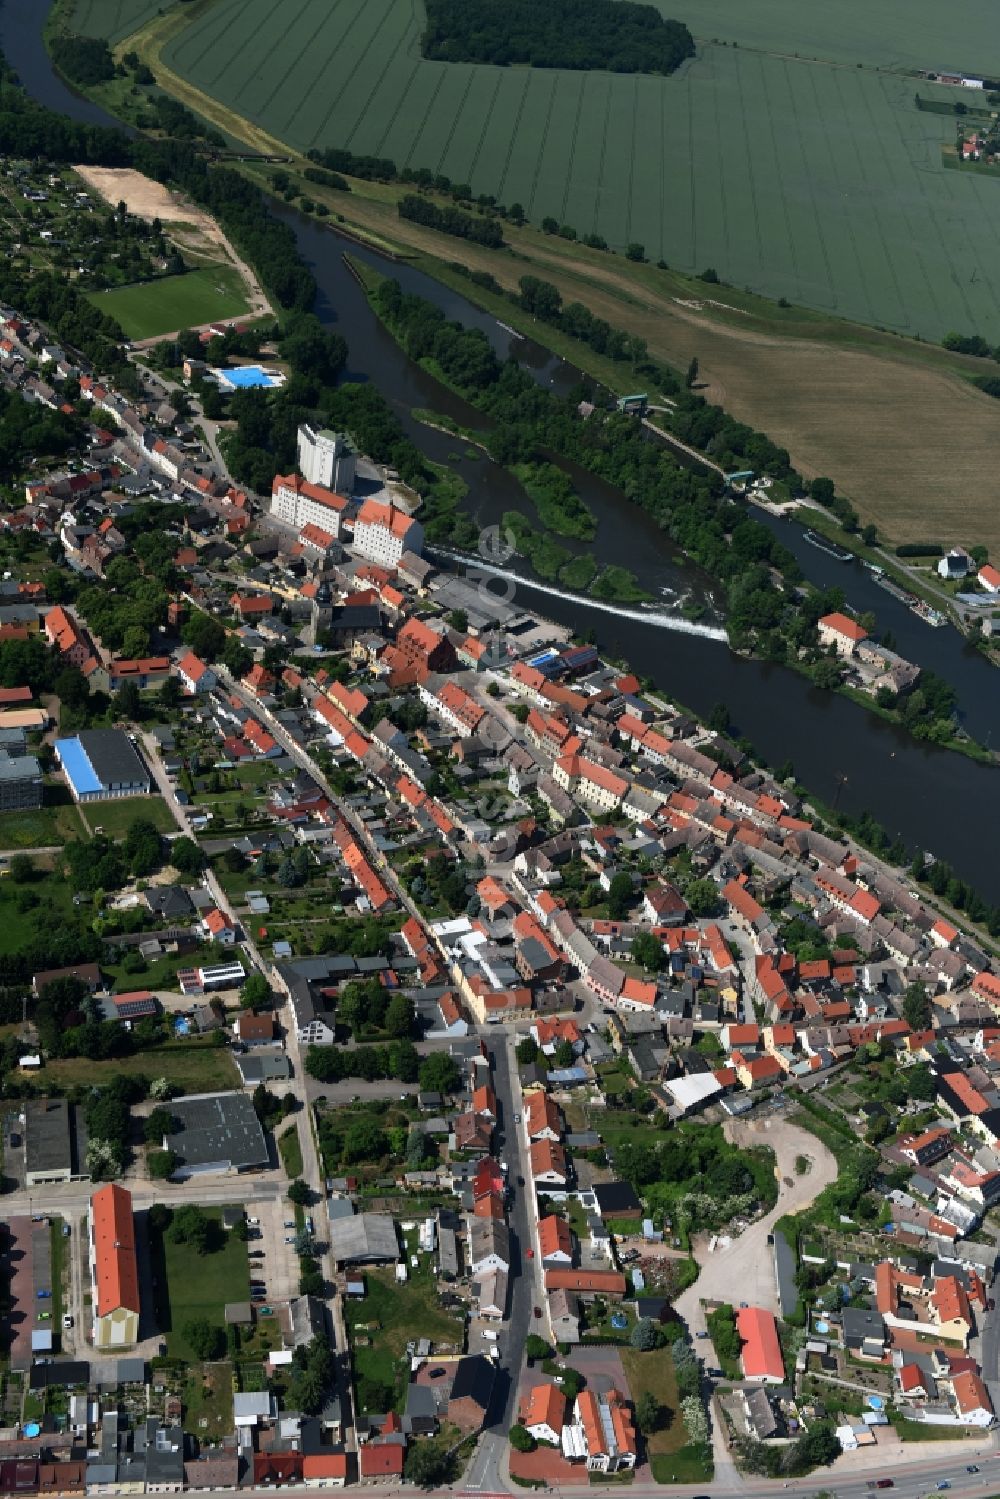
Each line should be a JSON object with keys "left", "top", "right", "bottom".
{"left": 675, "top": 1117, "right": 837, "bottom": 1333}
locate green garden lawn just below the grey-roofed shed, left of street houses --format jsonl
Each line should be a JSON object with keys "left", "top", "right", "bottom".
{"left": 343, "top": 1255, "right": 463, "bottom": 1409}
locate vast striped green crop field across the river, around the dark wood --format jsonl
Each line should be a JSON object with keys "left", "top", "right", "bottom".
{"left": 156, "top": 0, "right": 1000, "bottom": 339}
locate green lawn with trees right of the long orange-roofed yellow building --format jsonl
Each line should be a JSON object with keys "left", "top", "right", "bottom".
{"left": 150, "top": 1208, "right": 250, "bottom": 1363}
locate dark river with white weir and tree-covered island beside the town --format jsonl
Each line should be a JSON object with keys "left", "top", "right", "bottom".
{"left": 7, "top": 0, "right": 1000, "bottom": 904}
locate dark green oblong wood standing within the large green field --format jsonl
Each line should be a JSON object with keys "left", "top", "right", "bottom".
{"left": 421, "top": 0, "right": 694, "bottom": 73}
